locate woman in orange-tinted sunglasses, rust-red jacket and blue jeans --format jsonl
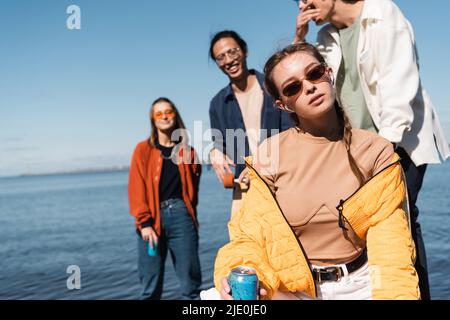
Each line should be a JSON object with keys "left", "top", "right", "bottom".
{"left": 128, "top": 98, "right": 201, "bottom": 299}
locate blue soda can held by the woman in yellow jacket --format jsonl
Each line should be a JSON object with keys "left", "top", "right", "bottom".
{"left": 228, "top": 266, "right": 258, "bottom": 300}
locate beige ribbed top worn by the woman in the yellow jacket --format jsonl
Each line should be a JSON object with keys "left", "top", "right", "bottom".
{"left": 254, "top": 128, "right": 394, "bottom": 265}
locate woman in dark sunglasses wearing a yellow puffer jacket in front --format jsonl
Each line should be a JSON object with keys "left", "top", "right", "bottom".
{"left": 214, "top": 43, "right": 420, "bottom": 300}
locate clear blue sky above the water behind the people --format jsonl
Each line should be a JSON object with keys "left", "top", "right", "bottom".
{"left": 0, "top": 0, "right": 450, "bottom": 176}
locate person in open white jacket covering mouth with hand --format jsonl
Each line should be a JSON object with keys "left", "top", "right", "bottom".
{"left": 294, "top": 0, "right": 450, "bottom": 300}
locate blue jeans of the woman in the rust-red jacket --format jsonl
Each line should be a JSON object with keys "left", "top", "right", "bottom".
{"left": 138, "top": 199, "right": 202, "bottom": 300}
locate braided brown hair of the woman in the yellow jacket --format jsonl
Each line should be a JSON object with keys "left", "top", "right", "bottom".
{"left": 264, "top": 42, "right": 365, "bottom": 186}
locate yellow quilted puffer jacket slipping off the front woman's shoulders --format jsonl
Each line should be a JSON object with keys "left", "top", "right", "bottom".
{"left": 214, "top": 154, "right": 420, "bottom": 299}
